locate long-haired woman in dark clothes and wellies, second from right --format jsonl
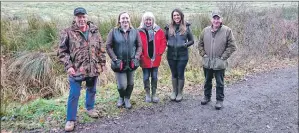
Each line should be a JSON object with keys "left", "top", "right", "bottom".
{"left": 165, "top": 9, "right": 194, "bottom": 102}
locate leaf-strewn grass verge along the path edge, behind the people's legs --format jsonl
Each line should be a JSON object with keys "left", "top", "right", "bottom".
{"left": 1, "top": 58, "right": 297, "bottom": 132}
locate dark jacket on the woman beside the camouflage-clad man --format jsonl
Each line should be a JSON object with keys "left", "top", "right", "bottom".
{"left": 106, "top": 27, "right": 142, "bottom": 71}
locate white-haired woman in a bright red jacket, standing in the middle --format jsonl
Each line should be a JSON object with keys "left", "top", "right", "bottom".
{"left": 139, "top": 12, "right": 166, "bottom": 103}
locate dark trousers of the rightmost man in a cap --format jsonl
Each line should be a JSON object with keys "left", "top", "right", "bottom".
{"left": 203, "top": 68, "right": 225, "bottom": 101}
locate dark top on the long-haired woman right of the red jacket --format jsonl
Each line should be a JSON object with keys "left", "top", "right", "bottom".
{"left": 165, "top": 23, "right": 194, "bottom": 60}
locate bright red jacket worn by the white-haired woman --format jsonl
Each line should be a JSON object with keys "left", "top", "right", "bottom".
{"left": 139, "top": 26, "right": 167, "bottom": 68}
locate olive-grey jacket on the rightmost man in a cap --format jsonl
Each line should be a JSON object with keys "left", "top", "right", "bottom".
{"left": 198, "top": 25, "right": 237, "bottom": 70}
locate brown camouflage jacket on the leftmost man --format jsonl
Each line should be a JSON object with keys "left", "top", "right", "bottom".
{"left": 57, "top": 22, "right": 106, "bottom": 77}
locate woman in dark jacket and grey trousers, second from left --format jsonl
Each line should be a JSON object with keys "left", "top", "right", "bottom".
{"left": 106, "top": 12, "right": 142, "bottom": 109}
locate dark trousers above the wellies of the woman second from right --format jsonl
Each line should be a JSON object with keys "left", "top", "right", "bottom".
{"left": 167, "top": 60, "right": 188, "bottom": 80}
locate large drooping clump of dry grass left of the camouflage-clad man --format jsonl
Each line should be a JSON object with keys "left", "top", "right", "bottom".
{"left": 1, "top": 52, "right": 67, "bottom": 102}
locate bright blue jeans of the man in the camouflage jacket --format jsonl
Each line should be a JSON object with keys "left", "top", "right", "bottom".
{"left": 66, "top": 77, "right": 98, "bottom": 121}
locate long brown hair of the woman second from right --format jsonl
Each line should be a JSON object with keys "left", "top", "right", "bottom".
{"left": 169, "top": 8, "right": 187, "bottom": 36}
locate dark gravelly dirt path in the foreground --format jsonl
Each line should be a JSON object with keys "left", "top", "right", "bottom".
{"left": 76, "top": 67, "right": 299, "bottom": 133}
